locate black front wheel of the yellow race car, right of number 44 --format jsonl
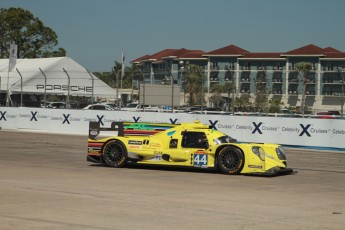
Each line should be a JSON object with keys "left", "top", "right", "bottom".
{"left": 217, "top": 146, "right": 244, "bottom": 174}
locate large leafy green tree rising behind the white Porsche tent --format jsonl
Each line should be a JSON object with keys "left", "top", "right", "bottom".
{"left": 0, "top": 7, "right": 66, "bottom": 58}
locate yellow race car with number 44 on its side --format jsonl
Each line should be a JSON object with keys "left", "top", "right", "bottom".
{"left": 87, "top": 121, "right": 293, "bottom": 176}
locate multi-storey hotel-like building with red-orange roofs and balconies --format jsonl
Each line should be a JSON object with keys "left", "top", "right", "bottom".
{"left": 132, "top": 44, "right": 345, "bottom": 113}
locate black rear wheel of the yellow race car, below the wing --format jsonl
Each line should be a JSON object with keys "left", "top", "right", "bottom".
{"left": 102, "top": 140, "right": 127, "bottom": 168}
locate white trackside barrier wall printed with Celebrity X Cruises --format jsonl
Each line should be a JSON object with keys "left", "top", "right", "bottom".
{"left": 0, "top": 107, "right": 345, "bottom": 151}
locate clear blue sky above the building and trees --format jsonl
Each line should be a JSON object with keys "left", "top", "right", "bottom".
{"left": 0, "top": 0, "right": 345, "bottom": 72}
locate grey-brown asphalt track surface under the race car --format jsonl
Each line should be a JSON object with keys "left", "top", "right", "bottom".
{"left": 0, "top": 130, "right": 345, "bottom": 230}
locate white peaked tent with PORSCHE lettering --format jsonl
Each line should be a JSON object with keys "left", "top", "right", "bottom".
{"left": 0, "top": 57, "right": 116, "bottom": 97}
